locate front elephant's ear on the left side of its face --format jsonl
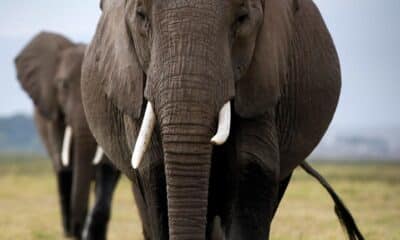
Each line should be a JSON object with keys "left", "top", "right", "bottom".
{"left": 84, "top": 0, "right": 144, "bottom": 118}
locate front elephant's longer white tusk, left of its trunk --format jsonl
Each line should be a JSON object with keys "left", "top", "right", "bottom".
{"left": 131, "top": 102, "right": 156, "bottom": 169}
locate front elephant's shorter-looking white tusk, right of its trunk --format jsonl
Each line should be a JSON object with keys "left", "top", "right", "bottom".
{"left": 211, "top": 101, "right": 231, "bottom": 145}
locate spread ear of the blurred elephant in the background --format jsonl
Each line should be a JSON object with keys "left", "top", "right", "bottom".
{"left": 15, "top": 32, "right": 73, "bottom": 119}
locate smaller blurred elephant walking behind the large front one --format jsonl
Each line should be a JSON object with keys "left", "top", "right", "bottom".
{"left": 15, "top": 32, "right": 120, "bottom": 239}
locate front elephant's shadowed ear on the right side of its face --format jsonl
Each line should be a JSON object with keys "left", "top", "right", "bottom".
{"left": 235, "top": 0, "right": 294, "bottom": 118}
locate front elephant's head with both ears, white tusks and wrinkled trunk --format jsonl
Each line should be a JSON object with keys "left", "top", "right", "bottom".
{"left": 82, "top": 0, "right": 295, "bottom": 239}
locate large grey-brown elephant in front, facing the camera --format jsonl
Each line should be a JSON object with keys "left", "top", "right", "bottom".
{"left": 82, "top": 0, "right": 362, "bottom": 240}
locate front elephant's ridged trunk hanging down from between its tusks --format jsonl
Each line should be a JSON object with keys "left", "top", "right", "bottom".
{"left": 161, "top": 98, "right": 214, "bottom": 240}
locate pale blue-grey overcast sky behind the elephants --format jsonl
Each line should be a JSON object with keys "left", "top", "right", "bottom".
{"left": 0, "top": 0, "right": 400, "bottom": 127}
